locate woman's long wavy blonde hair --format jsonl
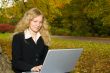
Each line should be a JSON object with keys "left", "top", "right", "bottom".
{"left": 15, "top": 8, "right": 50, "bottom": 46}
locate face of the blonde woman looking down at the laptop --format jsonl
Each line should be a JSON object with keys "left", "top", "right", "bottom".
{"left": 29, "top": 15, "right": 43, "bottom": 32}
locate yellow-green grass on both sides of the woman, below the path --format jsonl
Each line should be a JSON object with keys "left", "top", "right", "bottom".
{"left": 0, "top": 33, "right": 110, "bottom": 73}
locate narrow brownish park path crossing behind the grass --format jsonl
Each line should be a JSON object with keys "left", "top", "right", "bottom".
{"left": 52, "top": 35, "right": 110, "bottom": 44}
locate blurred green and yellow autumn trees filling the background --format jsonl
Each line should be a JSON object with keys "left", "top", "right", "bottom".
{"left": 0, "top": 0, "right": 110, "bottom": 36}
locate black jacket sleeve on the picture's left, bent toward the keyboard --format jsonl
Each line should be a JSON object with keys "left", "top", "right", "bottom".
{"left": 12, "top": 35, "right": 33, "bottom": 71}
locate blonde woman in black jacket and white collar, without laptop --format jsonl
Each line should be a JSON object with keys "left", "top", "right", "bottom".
{"left": 12, "top": 8, "right": 50, "bottom": 73}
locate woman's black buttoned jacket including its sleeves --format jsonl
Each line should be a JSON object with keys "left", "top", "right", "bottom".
{"left": 12, "top": 32, "right": 48, "bottom": 73}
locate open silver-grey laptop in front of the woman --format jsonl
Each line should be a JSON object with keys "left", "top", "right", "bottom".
{"left": 22, "top": 48, "right": 83, "bottom": 73}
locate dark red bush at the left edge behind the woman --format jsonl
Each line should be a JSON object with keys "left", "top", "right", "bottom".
{"left": 0, "top": 24, "right": 15, "bottom": 33}
